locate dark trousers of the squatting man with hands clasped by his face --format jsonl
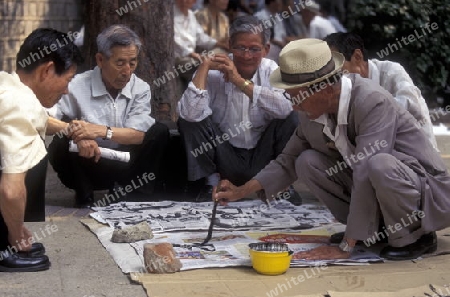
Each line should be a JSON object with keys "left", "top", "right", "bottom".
{"left": 178, "top": 112, "right": 298, "bottom": 185}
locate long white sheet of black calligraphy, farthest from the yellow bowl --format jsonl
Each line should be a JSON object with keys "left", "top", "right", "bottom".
{"left": 91, "top": 200, "right": 335, "bottom": 233}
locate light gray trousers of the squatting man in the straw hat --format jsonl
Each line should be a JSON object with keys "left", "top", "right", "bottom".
{"left": 295, "top": 149, "right": 424, "bottom": 247}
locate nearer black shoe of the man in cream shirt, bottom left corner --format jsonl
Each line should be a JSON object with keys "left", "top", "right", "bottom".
{"left": 0, "top": 253, "right": 50, "bottom": 272}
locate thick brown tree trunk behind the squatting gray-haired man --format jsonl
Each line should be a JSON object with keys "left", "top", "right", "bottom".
{"left": 84, "top": 0, "right": 177, "bottom": 120}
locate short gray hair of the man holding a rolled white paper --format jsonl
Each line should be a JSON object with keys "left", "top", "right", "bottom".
{"left": 97, "top": 25, "right": 142, "bottom": 58}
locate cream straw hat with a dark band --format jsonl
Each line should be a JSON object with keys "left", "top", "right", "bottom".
{"left": 270, "top": 38, "right": 345, "bottom": 89}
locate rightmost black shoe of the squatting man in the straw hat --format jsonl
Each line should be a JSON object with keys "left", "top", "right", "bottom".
{"left": 380, "top": 232, "right": 437, "bottom": 261}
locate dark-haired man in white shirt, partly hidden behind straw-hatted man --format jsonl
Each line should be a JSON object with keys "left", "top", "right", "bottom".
{"left": 324, "top": 33, "right": 437, "bottom": 149}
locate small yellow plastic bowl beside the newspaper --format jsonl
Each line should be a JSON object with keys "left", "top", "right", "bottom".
{"left": 249, "top": 245, "right": 292, "bottom": 275}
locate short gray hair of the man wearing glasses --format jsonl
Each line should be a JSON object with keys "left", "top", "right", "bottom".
{"left": 229, "top": 15, "right": 270, "bottom": 45}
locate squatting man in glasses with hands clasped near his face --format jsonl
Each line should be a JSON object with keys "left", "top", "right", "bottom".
{"left": 178, "top": 16, "right": 298, "bottom": 200}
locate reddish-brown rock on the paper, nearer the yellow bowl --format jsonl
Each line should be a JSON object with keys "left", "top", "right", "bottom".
{"left": 144, "top": 242, "right": 183, "bottom": 273}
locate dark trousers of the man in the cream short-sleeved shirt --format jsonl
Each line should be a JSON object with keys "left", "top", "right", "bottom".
{"left": 0, "top": 157, "right": 48, "bottom": 251}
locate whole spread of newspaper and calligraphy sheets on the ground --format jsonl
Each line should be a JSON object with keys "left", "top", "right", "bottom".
{"left": 91, "top": 200, "right": 382, "bottom": 273}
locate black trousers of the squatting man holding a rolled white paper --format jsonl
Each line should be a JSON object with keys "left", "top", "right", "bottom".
{"left": 48, "top": 123, "right": 169, "bottom": 200}
